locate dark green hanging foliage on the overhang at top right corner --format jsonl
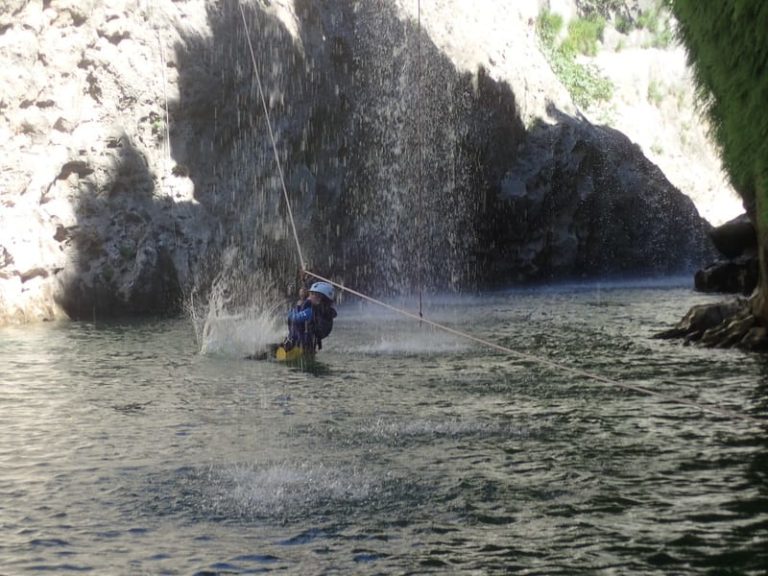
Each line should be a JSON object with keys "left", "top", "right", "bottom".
{"left": 672, "top": 0, "right": 768, "bottom": 213}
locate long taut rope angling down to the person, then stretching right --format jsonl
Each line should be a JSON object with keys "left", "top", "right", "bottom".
{"left": 238, "top": 2, "right": 762, "bottom": 423}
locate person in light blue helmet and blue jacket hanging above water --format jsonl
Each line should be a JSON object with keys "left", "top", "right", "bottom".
{"left": 283, "top": 282, "right": 336, "bottom": 354}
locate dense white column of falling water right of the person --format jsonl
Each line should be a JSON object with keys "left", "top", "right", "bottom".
{"left": 347, "top": 3, "right": 477, "bottom": 294}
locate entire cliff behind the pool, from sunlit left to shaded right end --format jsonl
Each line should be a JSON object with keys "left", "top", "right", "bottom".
{"left": 0, "top": 0, "right": 707, "bottom": 323}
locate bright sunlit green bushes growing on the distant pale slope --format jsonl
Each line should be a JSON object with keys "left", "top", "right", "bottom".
{"left": 536, "top": 11, "right": 613, "bottom": 107}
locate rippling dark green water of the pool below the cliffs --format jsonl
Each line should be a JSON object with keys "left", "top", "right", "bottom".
{"left": 0, "top": 285, "right": 768, "bottom": 575}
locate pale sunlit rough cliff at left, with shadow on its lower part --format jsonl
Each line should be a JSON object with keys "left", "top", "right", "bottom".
{"left": 0, "top": 0, "right": 213, "bottom": 322}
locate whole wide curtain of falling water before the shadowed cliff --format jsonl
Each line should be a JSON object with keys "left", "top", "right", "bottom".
{"left": 189, "top": 0, "right": 496, "bottom": 306}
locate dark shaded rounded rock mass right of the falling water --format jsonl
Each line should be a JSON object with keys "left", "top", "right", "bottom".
{"left": 480, "top": 117, "right": 712, "bottom": 281}
